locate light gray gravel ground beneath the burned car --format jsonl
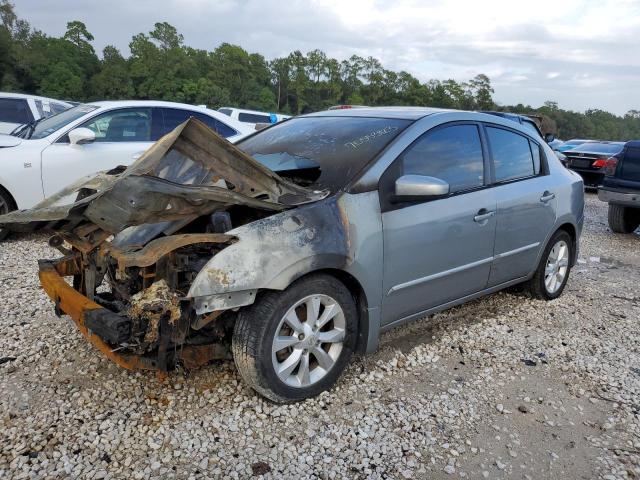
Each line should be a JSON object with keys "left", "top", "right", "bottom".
{"left": 0, "top": 195, "right": 640, "bottom": 479}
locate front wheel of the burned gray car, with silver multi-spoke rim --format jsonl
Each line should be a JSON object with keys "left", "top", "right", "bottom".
{"left": 232, "top": 274, "right": 358, "bottom": 403}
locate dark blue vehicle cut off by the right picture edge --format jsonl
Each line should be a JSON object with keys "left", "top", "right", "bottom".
{"left": 598, "top": 140, "right": 640, "bottom": 233}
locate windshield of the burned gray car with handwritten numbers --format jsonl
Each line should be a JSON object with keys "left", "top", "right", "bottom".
{"left": 238, "top": 117, "right": 411, "bottom": 192}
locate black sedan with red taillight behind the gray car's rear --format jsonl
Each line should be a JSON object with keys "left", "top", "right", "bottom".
{"left": 564, "top": 142, "right": 624, "bottom": 188}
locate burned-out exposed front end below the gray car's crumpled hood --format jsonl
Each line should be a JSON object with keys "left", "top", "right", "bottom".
{"left": 67, "top": 234, "right": 240, "bottom": 371}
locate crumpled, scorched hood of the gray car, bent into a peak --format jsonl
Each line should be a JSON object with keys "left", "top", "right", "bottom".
{"left": 0, "top": 118, "right": 328, "bottom": 235}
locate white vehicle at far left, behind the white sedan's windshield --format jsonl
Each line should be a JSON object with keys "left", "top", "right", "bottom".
{"left": 0, "top": 92, "right": 73, "bottom": 133}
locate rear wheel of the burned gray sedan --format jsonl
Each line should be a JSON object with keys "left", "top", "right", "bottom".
{"left": 526, "top": 230, "right": 574, "bottom": 300}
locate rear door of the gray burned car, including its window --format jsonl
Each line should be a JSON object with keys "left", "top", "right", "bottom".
{"left": 485, "top": 126, "right": 556, "bottom": 286}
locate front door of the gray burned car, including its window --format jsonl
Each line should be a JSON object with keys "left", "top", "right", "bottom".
{"left": 380, "top": 123, "right": 496, "bottom": 324}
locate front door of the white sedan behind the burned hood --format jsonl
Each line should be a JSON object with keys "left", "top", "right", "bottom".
{"left": 42, "top": 107, "right": 160, "bottom": 197}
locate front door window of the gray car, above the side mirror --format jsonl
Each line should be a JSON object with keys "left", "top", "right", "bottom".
{"left": 401, "top": 125, "right": 484, "bottom": 193}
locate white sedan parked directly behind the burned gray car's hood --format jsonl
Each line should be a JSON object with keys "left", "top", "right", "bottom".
{"left": 0, "top": 100, "right": 255, "bottom": 240}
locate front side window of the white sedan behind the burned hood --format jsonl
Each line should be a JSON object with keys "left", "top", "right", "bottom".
{"left": 81, "top": 108, "right": 151, "bottom": 142}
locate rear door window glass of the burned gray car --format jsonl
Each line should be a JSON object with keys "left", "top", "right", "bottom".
{"left": 487, "top": 127, "right": 540, "bottom": 182}
